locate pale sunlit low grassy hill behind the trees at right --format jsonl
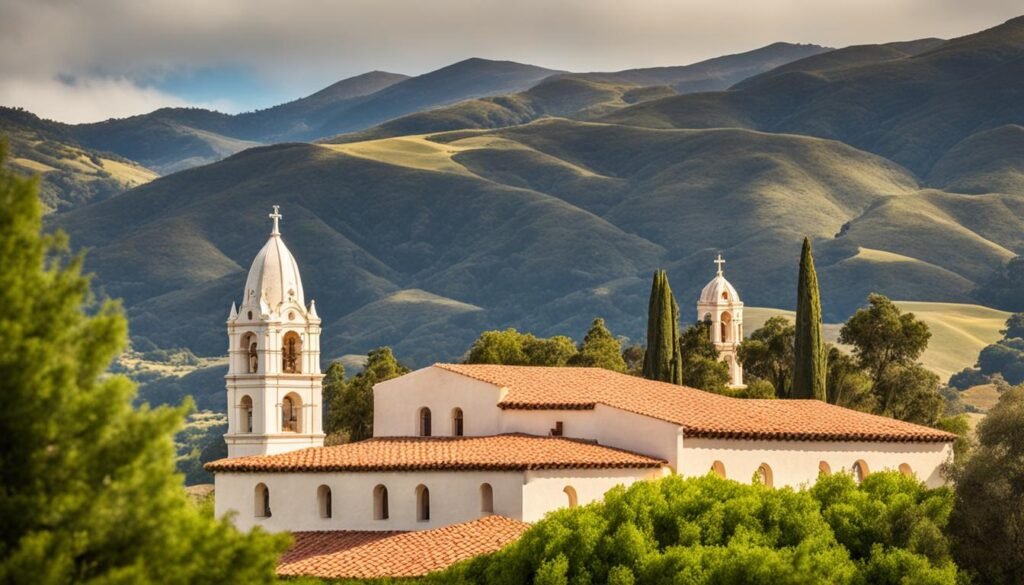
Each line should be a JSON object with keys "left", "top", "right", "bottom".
{"left": 743, "top": 301, "right": 1010, "bottom": 379}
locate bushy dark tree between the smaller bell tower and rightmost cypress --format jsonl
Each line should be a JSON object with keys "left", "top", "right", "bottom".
{"left": 738, "top": 317, "right": 797, "bottom": 399}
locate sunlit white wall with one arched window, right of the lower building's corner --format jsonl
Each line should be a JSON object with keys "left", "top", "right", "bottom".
{"left": 520, "top": 468, "right": 670, "bottom": 523}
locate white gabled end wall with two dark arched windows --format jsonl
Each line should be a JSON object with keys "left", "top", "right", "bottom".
{"left": 374, "top": 367, "right": 505, "bottom": 436}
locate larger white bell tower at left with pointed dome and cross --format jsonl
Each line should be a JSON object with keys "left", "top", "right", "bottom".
{"left": 224, "top": 205, "right": 324, "bottom": 457}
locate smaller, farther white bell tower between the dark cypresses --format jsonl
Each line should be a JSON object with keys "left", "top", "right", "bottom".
{"left": 697, "top": 254, "right": 743, "bottom": 387}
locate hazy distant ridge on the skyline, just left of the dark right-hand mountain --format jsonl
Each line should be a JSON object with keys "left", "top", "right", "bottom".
{"left": 566, "top": 43, "right": 833, "bottom": 93}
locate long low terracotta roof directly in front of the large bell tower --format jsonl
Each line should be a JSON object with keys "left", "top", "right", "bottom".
{"left": 206, "top": 434, "right": 666, "bottom": 471}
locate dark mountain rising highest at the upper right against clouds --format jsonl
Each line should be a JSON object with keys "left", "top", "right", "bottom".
{"left": 602, "top": 16, "right": 1024, "bottom": 176}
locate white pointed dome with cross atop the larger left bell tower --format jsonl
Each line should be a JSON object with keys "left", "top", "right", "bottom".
{"left": 242, "top": 205, "right": 305, "bottom": 315}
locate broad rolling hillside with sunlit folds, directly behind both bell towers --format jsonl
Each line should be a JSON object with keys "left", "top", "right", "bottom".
{"left": 53, "top": 111, "right": 1024, "bottom": 365}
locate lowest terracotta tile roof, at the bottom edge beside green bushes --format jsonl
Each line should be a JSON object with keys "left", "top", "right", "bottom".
{"left": 278, "top": 516, "right": 529, "bottom": 579}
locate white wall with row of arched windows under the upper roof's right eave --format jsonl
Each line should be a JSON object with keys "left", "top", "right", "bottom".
{"left": 678, "top": 438, "right": 952, "bottom": 488}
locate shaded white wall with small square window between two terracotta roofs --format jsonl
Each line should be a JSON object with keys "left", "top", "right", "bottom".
{"left": 501, "top": 405, "right": 683, "bottom": 469}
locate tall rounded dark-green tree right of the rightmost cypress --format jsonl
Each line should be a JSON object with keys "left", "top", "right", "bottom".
{"left": 839, "top": 294, "right": 938, "bottom": 416}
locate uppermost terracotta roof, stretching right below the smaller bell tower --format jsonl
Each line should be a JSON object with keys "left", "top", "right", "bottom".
{"left": 435, "top": 364, "right": 955, "bottom": 443}
